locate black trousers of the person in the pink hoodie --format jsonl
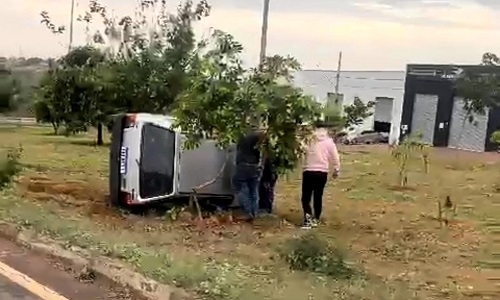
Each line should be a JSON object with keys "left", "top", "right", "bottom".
{"left": 301, "top": 171, "right": 328, "bottom": 219}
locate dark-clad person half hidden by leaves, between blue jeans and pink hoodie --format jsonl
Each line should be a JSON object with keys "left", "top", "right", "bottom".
{"left": 259, "top": 157, "right": 278, "bottom": 214}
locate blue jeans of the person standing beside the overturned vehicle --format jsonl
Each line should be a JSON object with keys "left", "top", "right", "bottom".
{"left": 233, "top": 164, "right": 260, "bottom": 218}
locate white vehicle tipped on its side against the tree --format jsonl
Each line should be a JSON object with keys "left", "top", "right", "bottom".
{"left": 109, "top": 113, "right": 235, "bottom": 206}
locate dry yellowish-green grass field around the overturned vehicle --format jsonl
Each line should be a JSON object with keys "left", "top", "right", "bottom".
{"left": 0, "top": 127, "right": 500, "bottom": 300}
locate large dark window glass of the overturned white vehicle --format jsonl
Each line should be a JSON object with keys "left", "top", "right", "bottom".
{"left": 139, "top": 123, "right": 175, "bottom": 199}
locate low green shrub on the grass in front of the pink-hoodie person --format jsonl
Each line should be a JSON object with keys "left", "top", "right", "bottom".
{"left": 279, "top": 233, "right": 355, "bottom": 279}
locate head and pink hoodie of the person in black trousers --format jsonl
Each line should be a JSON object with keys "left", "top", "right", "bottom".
{"left": 304, "top": 128, "right": 340, "bottom": 173}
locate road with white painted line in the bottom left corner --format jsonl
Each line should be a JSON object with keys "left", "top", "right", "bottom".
{"left": 0, "top": 237, "right": 139, "bottom": 300}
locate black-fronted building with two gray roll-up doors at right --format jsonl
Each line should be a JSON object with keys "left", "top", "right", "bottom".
{"left": 401, "top": 64, "right": 500, "bottom": 152}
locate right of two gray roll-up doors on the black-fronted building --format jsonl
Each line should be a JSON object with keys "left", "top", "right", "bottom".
{"left": 448, "top": 97, "right": 488, "bottom": 152}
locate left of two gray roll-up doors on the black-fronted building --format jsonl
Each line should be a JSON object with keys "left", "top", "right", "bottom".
{"left": 411, "top": 94, "right": 439, "bottom": 145}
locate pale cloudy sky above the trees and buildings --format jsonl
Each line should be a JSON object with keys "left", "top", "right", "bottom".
{"left": 0, "top": 0, "right": 500, "bottom": 71}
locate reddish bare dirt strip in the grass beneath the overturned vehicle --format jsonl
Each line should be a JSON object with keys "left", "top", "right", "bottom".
{"left": 19, "top": 175, "right": 289, "bottom": 245}
